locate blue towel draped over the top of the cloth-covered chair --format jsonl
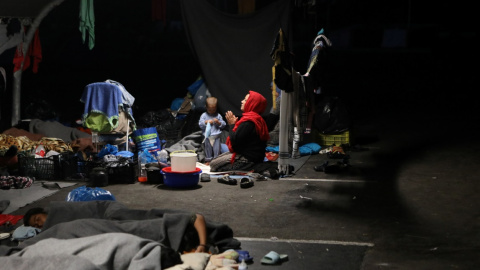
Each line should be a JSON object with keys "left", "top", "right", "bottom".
{"left": 80, "top": 82, "right": 123, "bottom": 120}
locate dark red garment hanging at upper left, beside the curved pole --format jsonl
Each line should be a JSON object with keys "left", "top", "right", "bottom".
{"left": 13, "top": 29, "right": 42, "bottom": 73}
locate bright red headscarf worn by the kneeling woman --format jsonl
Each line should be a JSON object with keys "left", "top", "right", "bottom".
{"left": 226, "top": 90, "right": 270, "bottom": 163}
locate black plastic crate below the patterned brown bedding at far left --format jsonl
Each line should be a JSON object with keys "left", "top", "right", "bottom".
{"left": 18, "top": 152, "right": 77, "bottom": 180}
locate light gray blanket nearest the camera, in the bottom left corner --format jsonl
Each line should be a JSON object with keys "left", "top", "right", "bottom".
{"left": 1, "top": 233, "right": 165, "bottom": 270}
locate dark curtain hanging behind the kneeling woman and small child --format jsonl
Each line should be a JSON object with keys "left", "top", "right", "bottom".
{"left": 180, "top": 0, "right": 291, "bottom": 116}
